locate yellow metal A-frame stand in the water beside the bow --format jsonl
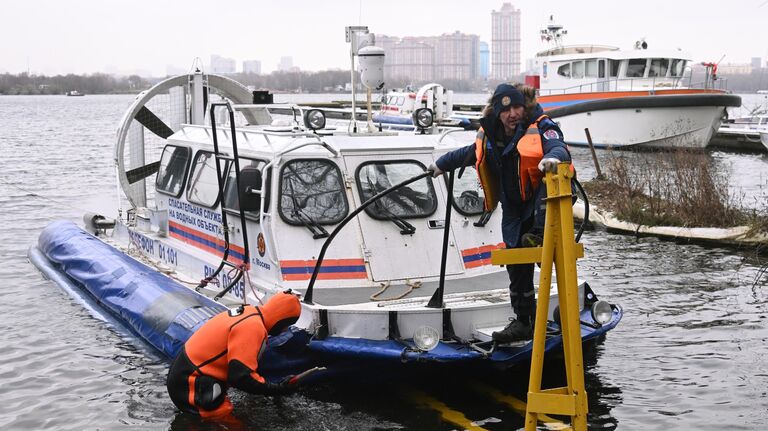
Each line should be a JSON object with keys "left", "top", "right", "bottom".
{"left": 491, "top": 163, "right": 587, "bottom": 431}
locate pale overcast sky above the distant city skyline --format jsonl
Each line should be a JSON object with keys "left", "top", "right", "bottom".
{"left": 0, "top": 0, "right": 768, "bottom": 76}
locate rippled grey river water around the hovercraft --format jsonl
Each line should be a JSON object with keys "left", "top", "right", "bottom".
{"left": 0, "top": 96, "right": 768, "bottom": 430}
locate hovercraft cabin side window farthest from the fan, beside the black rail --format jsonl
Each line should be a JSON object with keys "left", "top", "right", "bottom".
{"left": 223, "top": 157, "right": 271, "bottom": 220}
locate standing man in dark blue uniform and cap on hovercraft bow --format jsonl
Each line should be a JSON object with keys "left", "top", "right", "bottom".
{"left": 429, "top": 84, "right": 571, "bottom": 343}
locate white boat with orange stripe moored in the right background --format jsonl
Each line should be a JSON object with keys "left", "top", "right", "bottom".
{"left": 526, "top": 19, "right": 741, "bottom": 148}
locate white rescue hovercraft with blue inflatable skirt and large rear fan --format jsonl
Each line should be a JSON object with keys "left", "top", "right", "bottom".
{"left": 29, "top": 29, "right": 623, "bottom": 377}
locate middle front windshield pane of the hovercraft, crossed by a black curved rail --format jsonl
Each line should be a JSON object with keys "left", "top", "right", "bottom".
{"left": 355, "top": 160, "right": 437, "bottom": 220}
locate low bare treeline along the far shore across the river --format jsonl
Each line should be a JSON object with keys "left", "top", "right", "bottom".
{"left": 0, "top": 68, "right": 768, "bottom": 95}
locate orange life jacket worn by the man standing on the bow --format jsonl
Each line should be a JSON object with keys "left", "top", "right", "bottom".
{"left": 475, "top": 115, "right": 574, "bottom": 212}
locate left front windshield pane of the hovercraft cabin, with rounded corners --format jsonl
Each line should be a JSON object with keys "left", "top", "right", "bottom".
{"left": 278, "top": 159, "right": 349, "bottom": 226}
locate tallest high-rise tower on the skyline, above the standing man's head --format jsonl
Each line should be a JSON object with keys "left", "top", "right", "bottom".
{"left": 491, "top": 3, "right": 520, "bottom": 80}
